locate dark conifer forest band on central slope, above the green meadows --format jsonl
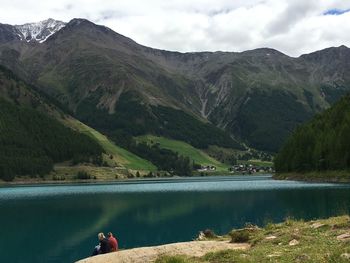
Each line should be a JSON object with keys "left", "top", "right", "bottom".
{"left": 77, "top": 92, "right": 243, "bottom": 149}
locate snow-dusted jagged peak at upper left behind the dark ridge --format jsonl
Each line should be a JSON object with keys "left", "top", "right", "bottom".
{"left": 15, "top": 18, "right": 66, "bottom": 43}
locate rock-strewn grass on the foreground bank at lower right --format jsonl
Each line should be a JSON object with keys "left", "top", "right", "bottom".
{"left": 156, "top": 215, "right": 350, "bottom": 263}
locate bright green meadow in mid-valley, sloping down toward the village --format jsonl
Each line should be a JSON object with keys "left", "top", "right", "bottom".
{"left": 136, "top": 135, "right": 229, "bottom": 172}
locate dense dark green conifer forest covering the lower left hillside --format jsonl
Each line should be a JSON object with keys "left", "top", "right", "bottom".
{"left": 0, "top": 99, "right": 102, "bottom": 180}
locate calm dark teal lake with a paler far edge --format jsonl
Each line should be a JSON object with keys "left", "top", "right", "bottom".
{"left": 0, "top": 175, "right": 350, "bottom": 263}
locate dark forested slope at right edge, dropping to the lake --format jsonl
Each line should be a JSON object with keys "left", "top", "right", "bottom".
{"left": 275, "top": 95, "right": 350, "bottom": 172}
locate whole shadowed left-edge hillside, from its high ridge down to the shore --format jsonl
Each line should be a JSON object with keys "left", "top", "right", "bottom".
{"left": 0, "top": 67, "right": 103, "bottom": 181}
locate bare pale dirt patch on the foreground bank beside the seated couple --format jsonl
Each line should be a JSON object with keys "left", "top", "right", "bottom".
{"left": 77, "top": 241, "right": 249, "bottom": 263}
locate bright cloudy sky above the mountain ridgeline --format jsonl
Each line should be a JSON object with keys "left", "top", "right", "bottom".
{"left": 0, "top": 0, "right": 350, "bottom": 56}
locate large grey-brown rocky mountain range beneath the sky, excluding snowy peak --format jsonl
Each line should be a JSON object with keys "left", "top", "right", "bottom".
{"left": 0, "top": 19, "right": 350, "bottom": 151}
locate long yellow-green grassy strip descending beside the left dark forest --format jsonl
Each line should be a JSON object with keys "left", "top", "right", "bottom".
{"left": 67, "top": 119, "right": 157, "bottom": 171}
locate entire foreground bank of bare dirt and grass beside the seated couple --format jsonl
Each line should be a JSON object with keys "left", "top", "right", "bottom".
{"left": 76, "top": 215, "right": 350, "bottom": 263}
